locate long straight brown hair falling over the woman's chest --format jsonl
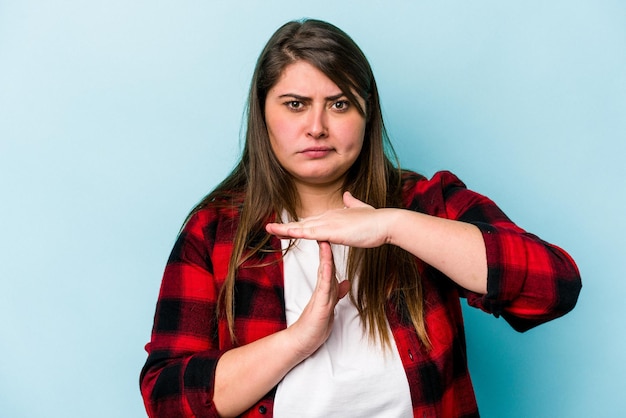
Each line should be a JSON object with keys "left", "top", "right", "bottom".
{"left": 190, "top": 19, "right": 429, "bottom": 346}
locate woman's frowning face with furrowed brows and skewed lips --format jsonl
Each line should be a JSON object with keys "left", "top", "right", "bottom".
{"left": 265, "top": 61, "right": 365, "bottom": 193}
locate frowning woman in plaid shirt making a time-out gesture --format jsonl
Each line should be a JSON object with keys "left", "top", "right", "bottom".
{"left": 141, "top": 20, "right": 581, "bottom": 417}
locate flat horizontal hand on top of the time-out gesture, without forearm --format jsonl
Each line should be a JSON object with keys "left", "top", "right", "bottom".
{"left": 265, "top": 192, "right": 393, "bottom": 248}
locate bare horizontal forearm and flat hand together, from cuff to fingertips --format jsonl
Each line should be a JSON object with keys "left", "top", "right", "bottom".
{"left": 265, "top": 192, "right": 487, "bottom": 294}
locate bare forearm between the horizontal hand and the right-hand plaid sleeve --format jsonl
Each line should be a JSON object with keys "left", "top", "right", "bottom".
{"left": 380, "top": 209, "right": 487, "bottom": 294}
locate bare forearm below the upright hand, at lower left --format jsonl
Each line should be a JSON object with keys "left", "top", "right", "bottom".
{"left": 213, "top": 329, "right": 304, "bottom": 417}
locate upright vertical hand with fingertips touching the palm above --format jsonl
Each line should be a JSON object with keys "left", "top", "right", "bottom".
{"left": 287, "top": 242, "right": 350, "bottom": 359}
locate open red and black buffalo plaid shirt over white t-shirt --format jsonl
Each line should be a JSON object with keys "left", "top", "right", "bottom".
{"left": 141, "top": 172, "right": 581, "bottom": 418}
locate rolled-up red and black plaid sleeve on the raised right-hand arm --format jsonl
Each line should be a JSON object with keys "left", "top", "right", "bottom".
{"left": 413, "top": 172, "right": 581, "bottom": 332}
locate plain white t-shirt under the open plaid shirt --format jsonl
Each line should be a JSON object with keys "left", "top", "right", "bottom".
{"left": 274, "top": 240, "right": 413, "bottom": 418}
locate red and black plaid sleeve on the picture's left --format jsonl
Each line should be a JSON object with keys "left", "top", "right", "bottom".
{"left": 140, "top": 211, "right": 225, "bottom": 418}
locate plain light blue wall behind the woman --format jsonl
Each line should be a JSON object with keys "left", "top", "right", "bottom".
{"left": 0, "top": 0, "right": 626, "bottom": 418}
